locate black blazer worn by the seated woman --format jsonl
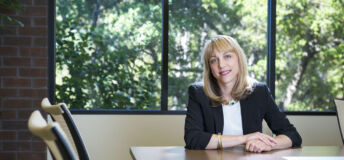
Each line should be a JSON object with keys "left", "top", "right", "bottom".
{"left": 184, "top": 83, "right": 302, "bottom": 149}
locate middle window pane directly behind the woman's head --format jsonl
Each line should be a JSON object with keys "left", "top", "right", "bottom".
{"left": 168, "top": 0, "right": 267, "bottom": 110}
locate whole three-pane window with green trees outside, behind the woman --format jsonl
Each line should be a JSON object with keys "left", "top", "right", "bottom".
{"left": 49, "top": 0, "right": 344, "bottom": 111}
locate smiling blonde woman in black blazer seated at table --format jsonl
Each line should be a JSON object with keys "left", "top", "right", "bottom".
{"left": 184, "top": 35, "right": 302, "bottom": 152}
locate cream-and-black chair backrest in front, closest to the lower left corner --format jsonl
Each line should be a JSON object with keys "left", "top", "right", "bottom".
{"left": 28, "top": 110, "right": 77, "bottom": 160}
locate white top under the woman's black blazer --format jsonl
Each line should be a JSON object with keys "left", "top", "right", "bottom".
{"left": 222, "top": 101, "right": 243, "bottom": 135}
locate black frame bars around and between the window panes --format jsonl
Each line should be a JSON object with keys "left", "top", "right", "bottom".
{"left": 48, "top": 0, "right": 336, "bottom": 116}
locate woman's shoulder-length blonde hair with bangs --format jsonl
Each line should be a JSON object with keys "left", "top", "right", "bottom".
{"left": 203, "top": 35, "right": 253, "bottom": 106}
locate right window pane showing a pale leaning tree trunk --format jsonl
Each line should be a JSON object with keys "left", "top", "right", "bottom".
{"left": 276, "top": 0, "right": 344, "bottom": 111}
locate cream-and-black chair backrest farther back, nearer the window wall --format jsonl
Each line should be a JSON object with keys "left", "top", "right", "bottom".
{"left": 41, "top": 98, "right": 89, "bottom": 160}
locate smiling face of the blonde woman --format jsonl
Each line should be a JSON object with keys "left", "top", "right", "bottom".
{"left": 209, "top": 51, "right": 239, "bottom": 85}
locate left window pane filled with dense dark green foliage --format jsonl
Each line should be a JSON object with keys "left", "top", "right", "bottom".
{"left": 56, "top": 0, "right": 161, "bottom": 110}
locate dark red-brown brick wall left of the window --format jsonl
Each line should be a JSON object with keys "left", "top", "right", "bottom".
{"left": 0, "top": 0, "right": 48, "bottom": 160}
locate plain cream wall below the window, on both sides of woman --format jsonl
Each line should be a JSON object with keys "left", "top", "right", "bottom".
{"left": 73, "top": 115, "right": 341, "bottom": 160}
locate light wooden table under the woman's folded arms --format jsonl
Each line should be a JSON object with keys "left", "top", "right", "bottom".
{"left": 130, "top": 145, "right": 344, "bottom": 160}
